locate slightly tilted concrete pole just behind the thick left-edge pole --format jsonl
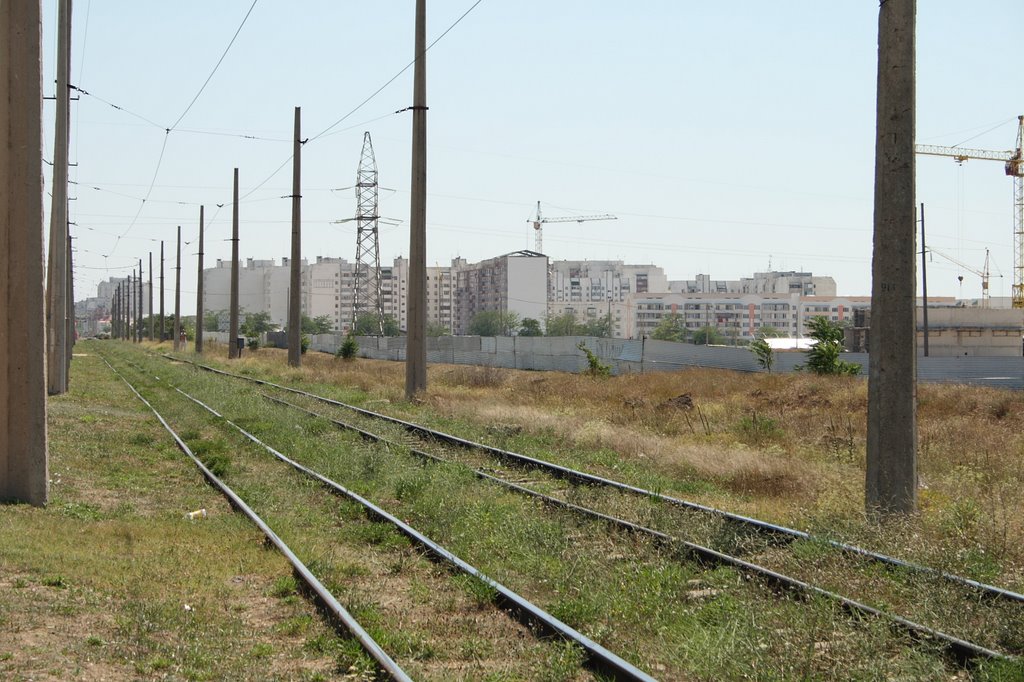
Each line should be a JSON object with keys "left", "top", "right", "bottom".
{"left": 46, "top": 0, "right": 71, "bottom": 395}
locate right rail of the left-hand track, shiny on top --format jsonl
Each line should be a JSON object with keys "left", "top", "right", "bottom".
{"left": 149, "top": 378, "right": 655, "bottom": 682}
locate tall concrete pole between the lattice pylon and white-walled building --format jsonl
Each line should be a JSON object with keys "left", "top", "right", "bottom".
{"left": 406, "top": 0, "right": 427, "bottom": 400}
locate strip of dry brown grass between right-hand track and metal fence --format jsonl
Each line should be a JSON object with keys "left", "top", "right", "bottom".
{"left": 176, "top": 350, "right": 1024, "bottom": 585}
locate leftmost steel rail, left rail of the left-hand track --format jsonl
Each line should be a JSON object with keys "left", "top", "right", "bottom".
{"left": 99, "top": 355, "right": 412, "bottom": 682}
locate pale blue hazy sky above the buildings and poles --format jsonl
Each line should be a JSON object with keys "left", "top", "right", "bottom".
{"left": 43, "top": 0, "right": 1024, "bottom": 312}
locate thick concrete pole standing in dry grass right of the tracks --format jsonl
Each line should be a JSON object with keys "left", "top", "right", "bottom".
{"left": 865, "top": 0, "right": 918, "bottom": 517}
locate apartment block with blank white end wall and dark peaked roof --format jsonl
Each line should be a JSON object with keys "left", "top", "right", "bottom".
{"left": 453, "top": 251, "right": 548, "bottom": 334}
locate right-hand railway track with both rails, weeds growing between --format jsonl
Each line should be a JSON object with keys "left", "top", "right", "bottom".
{"left": 151, "top": 350, "right": 1024, "bottom": 663}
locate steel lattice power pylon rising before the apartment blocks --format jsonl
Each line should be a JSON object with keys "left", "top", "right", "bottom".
{"left": 352, "top": 131, "right": 384, "bottom": 336}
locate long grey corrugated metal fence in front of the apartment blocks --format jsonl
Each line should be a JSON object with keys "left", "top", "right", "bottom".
{"left": 310, "top": 334, "right": 1024, "bottom": 390}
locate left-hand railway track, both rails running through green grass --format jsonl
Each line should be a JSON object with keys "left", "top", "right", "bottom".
{"left": 102, "top": 350, "right": 655, "bottom": 682}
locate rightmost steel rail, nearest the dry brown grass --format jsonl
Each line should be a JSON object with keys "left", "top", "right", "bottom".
{"left": 163, "top": 353, "right": 1024, "bottom": 603}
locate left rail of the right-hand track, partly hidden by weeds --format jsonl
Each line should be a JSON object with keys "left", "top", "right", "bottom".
{"left": 261, "top": 393, "right": 1013, "bottom": 664}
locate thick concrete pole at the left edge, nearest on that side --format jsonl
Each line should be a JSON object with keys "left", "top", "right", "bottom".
{"left": 0, "top": 0, "right": 49, "bottom": 499}
